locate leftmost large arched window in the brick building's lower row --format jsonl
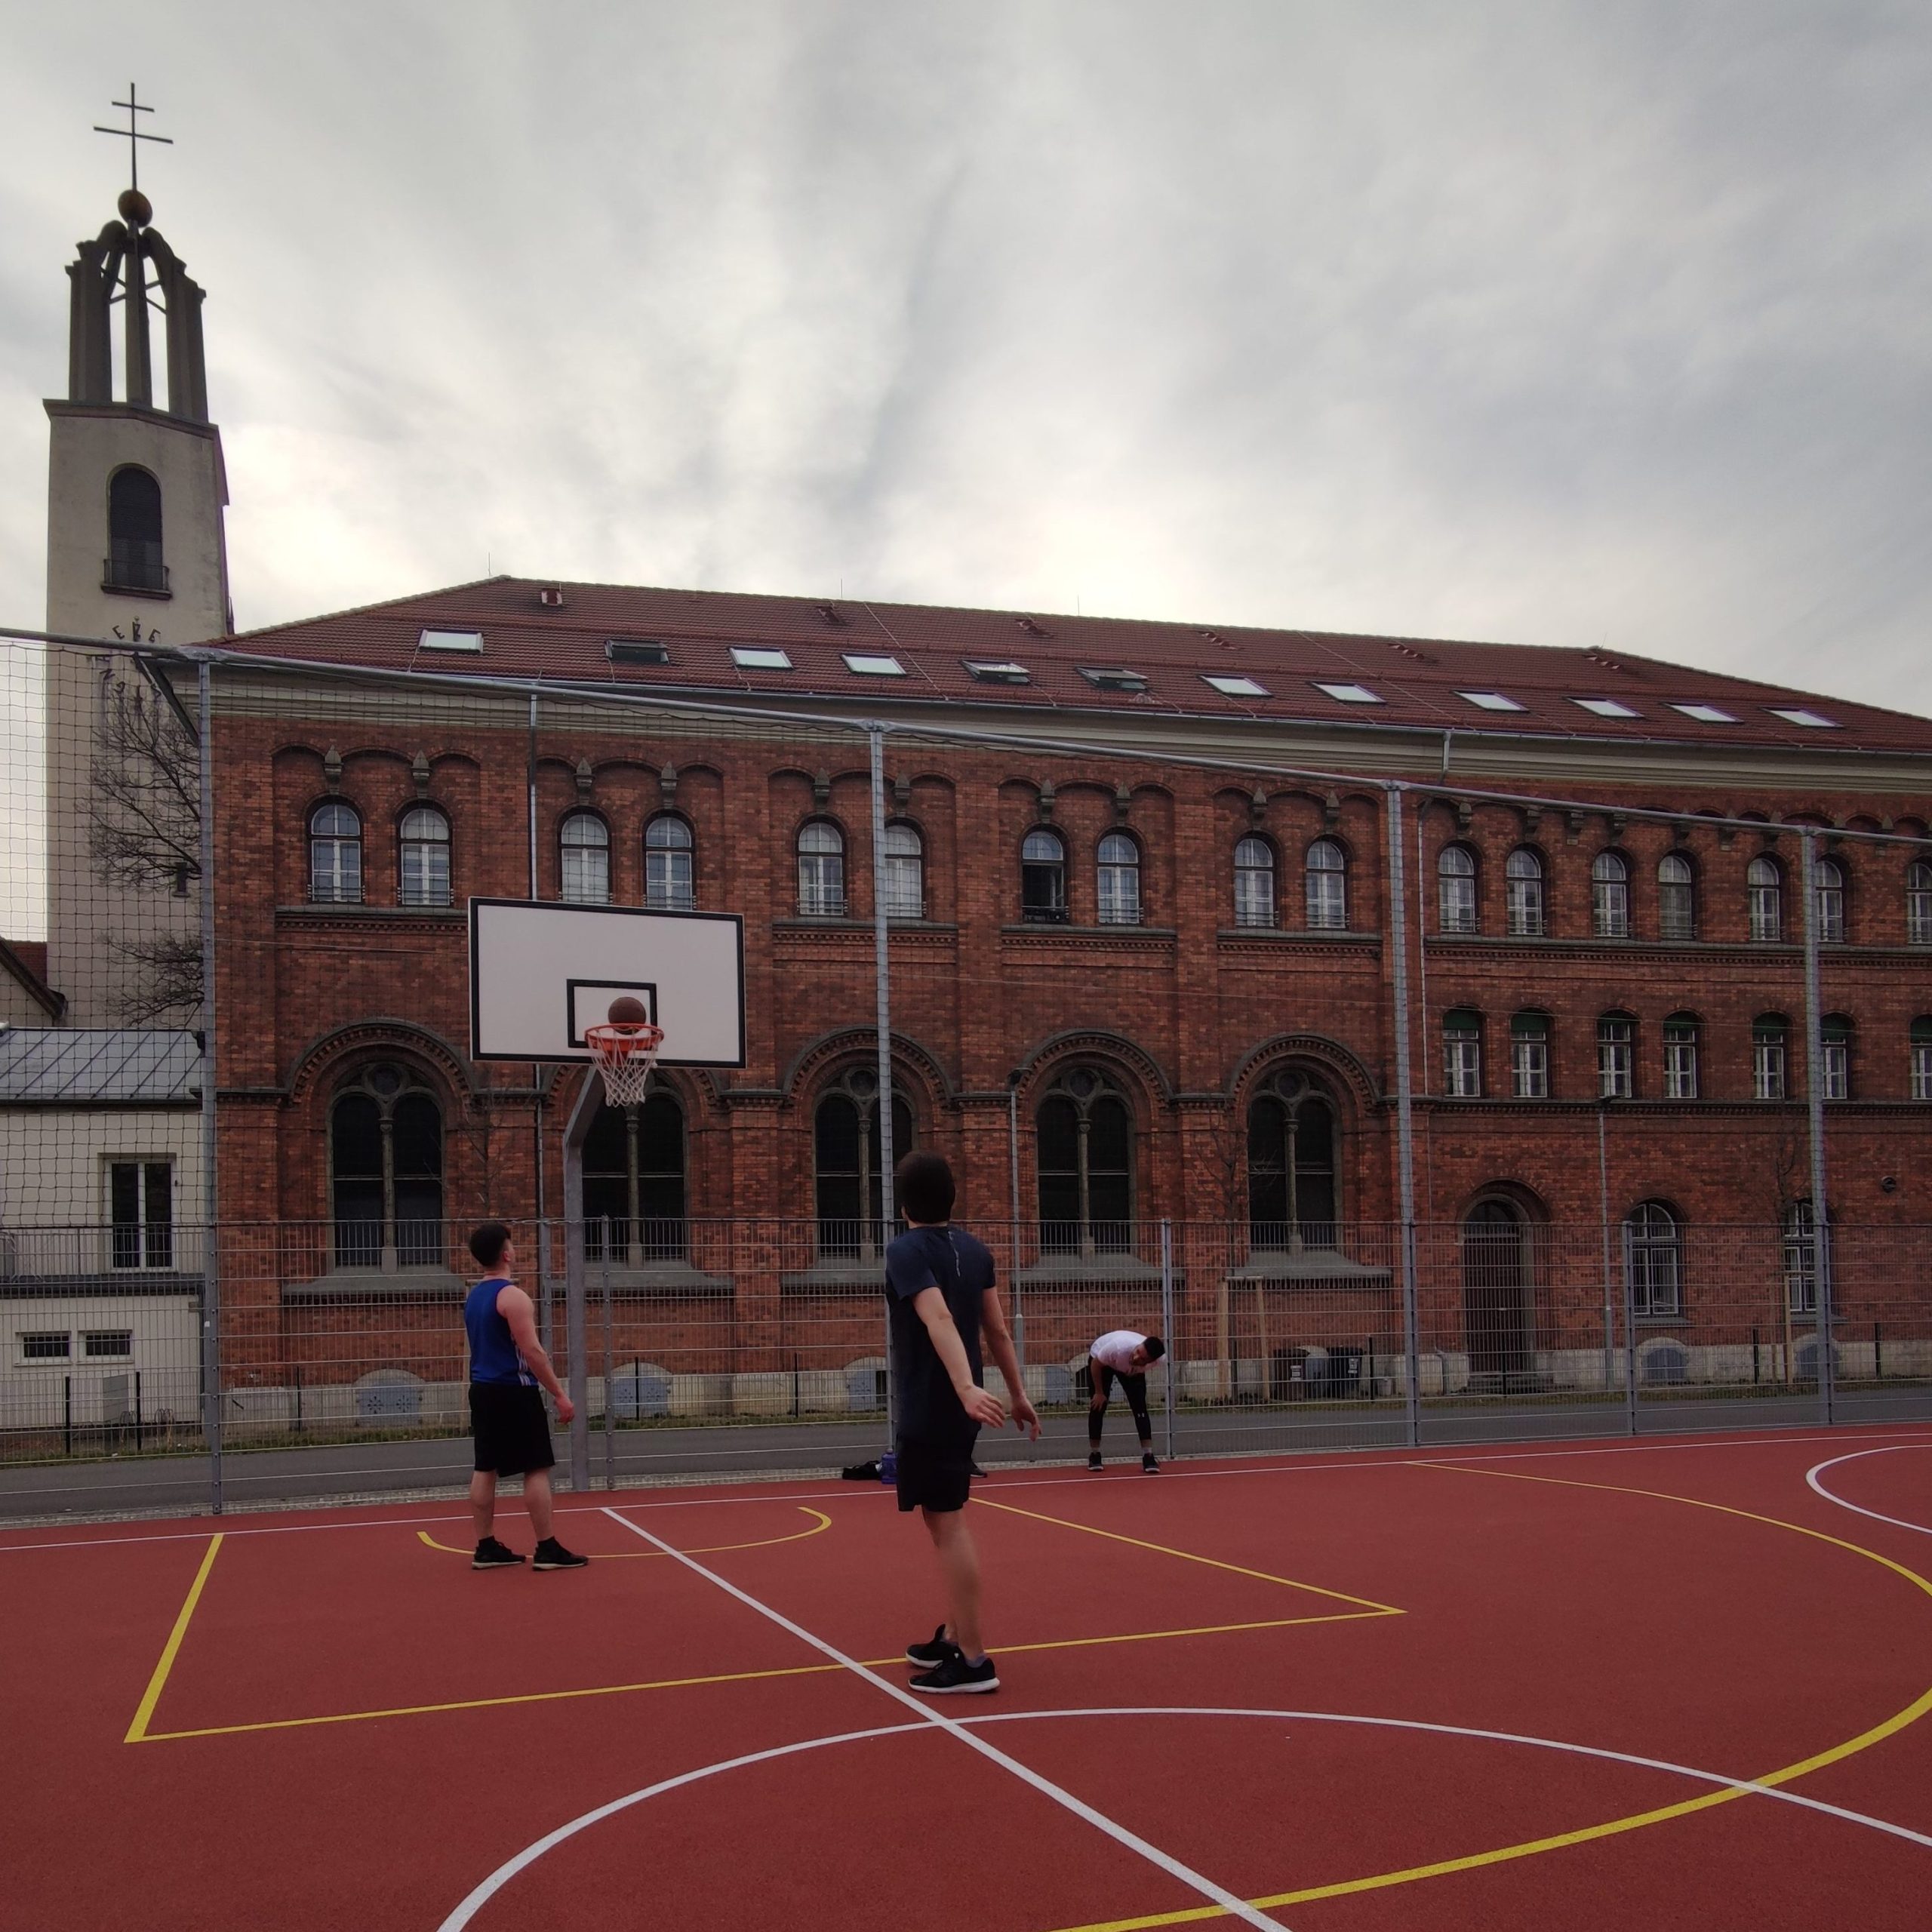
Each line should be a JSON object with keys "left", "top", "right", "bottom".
{"left": 328, "top": 1060, "right": 448, "bottom": 1269}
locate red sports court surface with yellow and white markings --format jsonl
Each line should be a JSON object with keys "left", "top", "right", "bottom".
{"left": 0, "top": 1428, "right": 1932, "bottom": 1932}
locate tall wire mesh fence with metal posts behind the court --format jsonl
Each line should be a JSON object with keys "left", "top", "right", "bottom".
{"left": 0, "top": 632, "right": 1932, "bottom": 1515}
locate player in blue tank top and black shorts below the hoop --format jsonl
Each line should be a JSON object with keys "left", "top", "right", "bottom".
{"left": 463, "top": 1221, "right": 589, "bottom": 1571}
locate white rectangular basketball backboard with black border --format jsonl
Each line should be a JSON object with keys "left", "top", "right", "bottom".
{"left": 469, "top": 898, "right": 744, "bottom": 1066}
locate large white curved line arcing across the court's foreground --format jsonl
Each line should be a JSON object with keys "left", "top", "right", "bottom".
{"left": 437, "top": 1704, "right": 1932, "bottom": 1932}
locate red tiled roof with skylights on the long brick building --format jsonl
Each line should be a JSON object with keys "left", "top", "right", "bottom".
{"left": 230, "top": 577, "right": 1932, "bottom": 755}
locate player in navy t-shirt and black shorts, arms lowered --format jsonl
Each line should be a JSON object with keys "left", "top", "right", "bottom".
{"left": 884, "top": 1153, "right": 1039, "bottom": 1693}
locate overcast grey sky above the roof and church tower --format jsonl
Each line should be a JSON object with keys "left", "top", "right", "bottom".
{"left": 0, "top": 0, "right": 1932, "bottom": 711}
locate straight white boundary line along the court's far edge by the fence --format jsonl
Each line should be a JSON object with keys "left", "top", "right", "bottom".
{"left": 15, "top": 1422, "right": 1932, "bottom": 1555}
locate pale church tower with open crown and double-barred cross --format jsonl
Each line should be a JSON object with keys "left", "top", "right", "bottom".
{"left": 46, "top": 102, "right": 234, "bottom": 1026}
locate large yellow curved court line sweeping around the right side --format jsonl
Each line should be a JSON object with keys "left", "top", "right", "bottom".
{"left": 1035, "top": 1463, "right": 1932, "bottom": 1932}
